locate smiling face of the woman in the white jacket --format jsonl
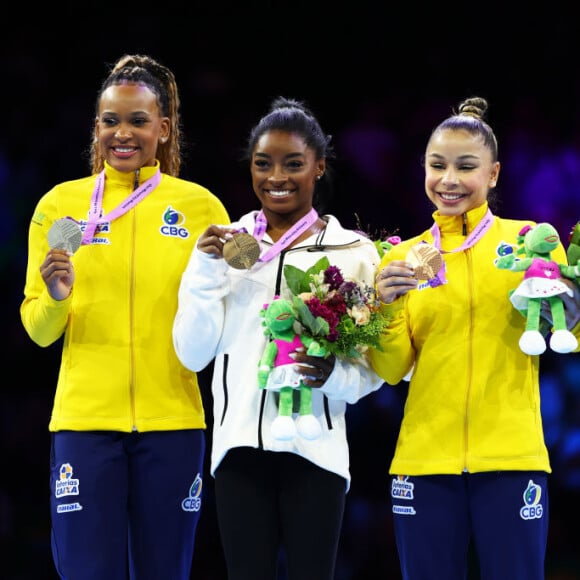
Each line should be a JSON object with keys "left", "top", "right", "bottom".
{"left": 250, "top": 130, "right": 326, "bottom": 220}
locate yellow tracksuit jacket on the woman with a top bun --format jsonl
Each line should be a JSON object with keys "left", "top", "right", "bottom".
{"left": 370, "top": 204, "right": 580, "bottom": 475}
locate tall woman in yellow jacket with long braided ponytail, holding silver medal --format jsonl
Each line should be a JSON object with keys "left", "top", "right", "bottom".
{"left": 21, "top": 55, "right": 229, "bottom": 580}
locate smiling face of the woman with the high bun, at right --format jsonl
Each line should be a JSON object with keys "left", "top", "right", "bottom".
{"left": 425, "top": 129, "right": 500, "bottom": 216}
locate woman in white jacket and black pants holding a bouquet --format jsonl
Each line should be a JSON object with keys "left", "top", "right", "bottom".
{"left": 173, "top": 98, "right": 382, "bottom": 580}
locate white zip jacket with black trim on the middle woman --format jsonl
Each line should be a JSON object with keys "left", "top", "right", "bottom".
{"left": 173, "top": 211, "right": 383, "bottom": 490}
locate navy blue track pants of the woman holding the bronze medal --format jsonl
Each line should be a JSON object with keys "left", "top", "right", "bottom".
{"left": 391, "top": 471, "right": 548, "bottom": 580}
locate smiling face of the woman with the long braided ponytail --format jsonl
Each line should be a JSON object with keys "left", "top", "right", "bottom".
{"left": 95, "top": 83, "right": 169, "bottom": 172}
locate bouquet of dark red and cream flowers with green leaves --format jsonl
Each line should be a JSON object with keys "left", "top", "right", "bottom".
{"left": 284, "top": 257, "right": 386, "bottom": 358}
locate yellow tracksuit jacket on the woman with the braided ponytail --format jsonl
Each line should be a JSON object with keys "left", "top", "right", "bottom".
{"left": 20, "top": 164, "right": 230, "bottom": 432}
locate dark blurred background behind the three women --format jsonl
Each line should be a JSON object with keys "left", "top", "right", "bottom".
{"left": 0, "top": 5, "right": 580, "bottom": 580}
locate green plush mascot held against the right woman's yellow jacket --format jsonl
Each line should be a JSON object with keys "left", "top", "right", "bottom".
{"left": 495, "top": 223, "right": 578, "bottom": 355}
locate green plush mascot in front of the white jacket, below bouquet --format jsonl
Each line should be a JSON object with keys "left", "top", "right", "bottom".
{"left": 258, "top": 297, "right": 325, "bottom": 441}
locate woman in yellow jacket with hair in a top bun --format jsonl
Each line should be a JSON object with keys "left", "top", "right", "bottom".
{"left": 371, "top": 97, "right": 580, "bottom": 580}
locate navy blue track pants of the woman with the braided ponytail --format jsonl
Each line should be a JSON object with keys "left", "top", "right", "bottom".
{"left": 50, "top": 429, "right": 205, "bottom": 580}
